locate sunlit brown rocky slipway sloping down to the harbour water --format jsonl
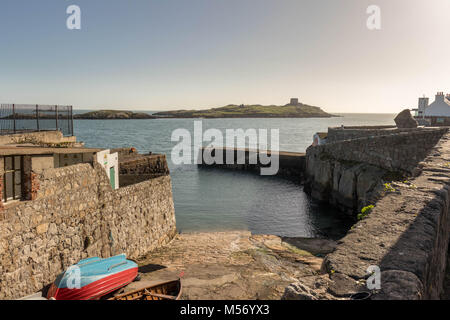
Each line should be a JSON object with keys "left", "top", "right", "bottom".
{"left": 132, "top": 231, "right": 328, "bottom": 300}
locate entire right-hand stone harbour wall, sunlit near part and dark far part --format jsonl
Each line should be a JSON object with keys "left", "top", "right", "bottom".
{"left": 188, "top": 128, "right": 450, "bottom": 300}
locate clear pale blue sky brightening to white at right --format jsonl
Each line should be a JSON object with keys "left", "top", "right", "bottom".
{"left": 0, "top": 0, "right": 450, "bottom": 113}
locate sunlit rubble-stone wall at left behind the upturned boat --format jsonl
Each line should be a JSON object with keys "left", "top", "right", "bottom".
{"left": 0, "top": 164, "right": 176, "bottom": 299}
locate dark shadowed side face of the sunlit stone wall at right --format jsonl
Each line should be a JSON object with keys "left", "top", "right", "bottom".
{"left": 374, "top": 187, "right": 449, "bottom": 300}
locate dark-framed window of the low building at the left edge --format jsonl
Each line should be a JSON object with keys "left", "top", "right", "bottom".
{"left": 3, "top": 156, "right": 23, "bottom": 202}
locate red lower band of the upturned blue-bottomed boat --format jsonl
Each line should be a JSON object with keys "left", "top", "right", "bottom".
{"left": 47, "top": 268, "right": 138, "bottom": 300}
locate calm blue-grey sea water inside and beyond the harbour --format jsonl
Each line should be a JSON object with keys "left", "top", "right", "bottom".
{"left": 74, "top": 111, "right": 395, "bottom": 238}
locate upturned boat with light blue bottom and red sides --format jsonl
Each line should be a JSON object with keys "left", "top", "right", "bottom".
{"left": 47, "top": 254, "right": 138, "bottom": 300}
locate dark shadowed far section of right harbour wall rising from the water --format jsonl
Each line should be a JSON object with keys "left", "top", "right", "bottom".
{"left": 305, "top": 129, "right": 447, "bottom": 214}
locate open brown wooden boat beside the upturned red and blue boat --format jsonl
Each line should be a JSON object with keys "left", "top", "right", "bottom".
{"left": 108, "top": 278, "right": 183, "bottom": 300}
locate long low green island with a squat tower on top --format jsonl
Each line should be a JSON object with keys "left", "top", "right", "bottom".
{"left": 153, "top": 103, "right": 336, "bottom": 118}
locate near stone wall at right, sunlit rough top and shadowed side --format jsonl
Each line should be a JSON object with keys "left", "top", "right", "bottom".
{"left": 322, "top": 134, "right": 450, "bottom": 299}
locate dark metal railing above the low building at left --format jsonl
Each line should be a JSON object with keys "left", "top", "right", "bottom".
{"left": 0, "top": 104, "right": 73, "bottom": 136}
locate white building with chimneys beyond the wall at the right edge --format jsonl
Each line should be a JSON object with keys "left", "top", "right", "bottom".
{"left": 415, "top": 92, "right": 450, "bottom": 126}
